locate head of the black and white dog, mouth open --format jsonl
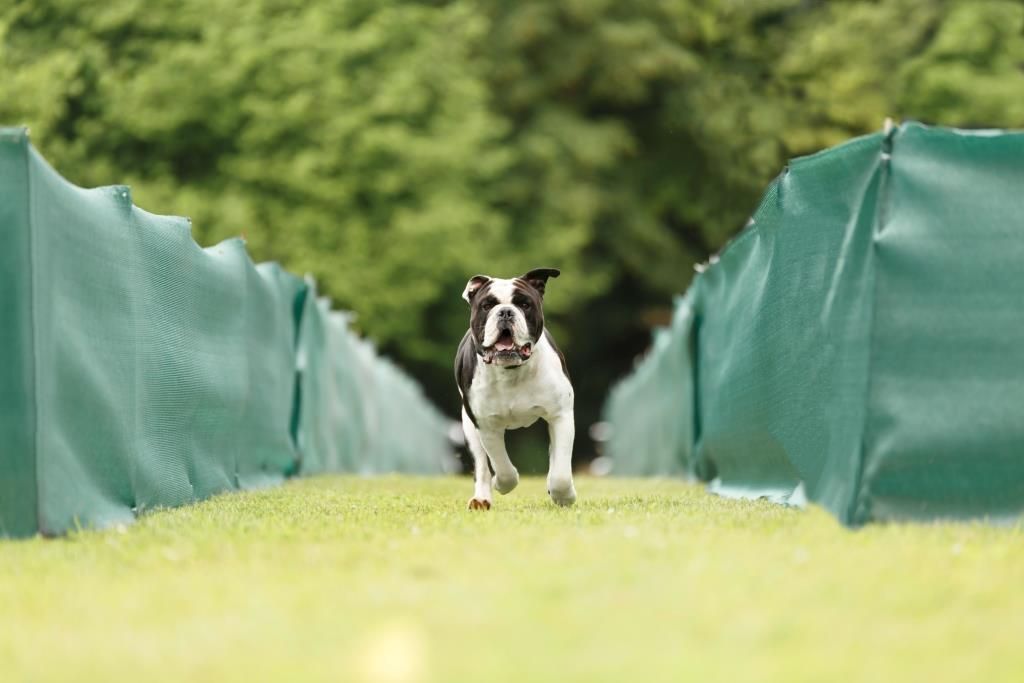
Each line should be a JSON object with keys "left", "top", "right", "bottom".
{"left": 462, "top": 268, "right": 559, "bottom": 368}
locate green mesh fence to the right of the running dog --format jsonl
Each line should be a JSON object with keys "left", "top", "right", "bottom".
{"left": 606, "top": 124, "right": 1024, "bottom": 524}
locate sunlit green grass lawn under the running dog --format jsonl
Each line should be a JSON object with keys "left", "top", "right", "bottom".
{"left": 0, "top": 477, "right": 1024, "bottom": 683}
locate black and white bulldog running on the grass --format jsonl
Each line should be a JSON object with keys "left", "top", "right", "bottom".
{"left": 455, "top": 268, "right": 575, "bottom": 510}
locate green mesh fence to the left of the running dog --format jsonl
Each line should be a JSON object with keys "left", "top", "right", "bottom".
{"left": 0, "top": 129, "right": 450, "bottom": 536}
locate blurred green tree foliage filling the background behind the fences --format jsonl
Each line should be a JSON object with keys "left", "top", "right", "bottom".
{"left": 0, "top": 0, "right": 1024, "bottom": 444}
